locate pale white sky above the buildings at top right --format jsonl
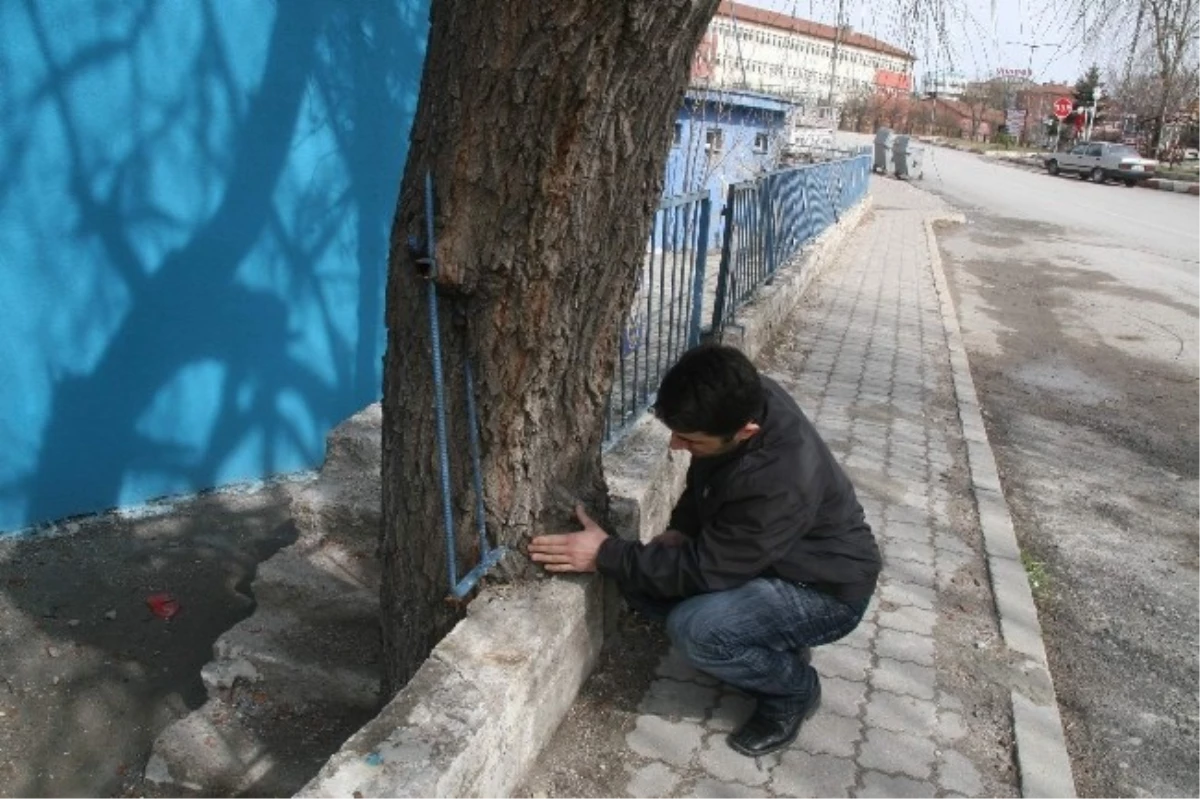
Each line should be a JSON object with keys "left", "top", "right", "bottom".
{"left": 729, "top": 0, "right": 1104, "bottom": 84}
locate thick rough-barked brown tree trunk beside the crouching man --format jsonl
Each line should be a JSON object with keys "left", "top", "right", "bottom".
{"left": 382, "top": 0, "right": 718, "bottom": 693}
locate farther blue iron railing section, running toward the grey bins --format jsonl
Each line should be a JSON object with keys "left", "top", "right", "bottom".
{"left": 712, "top": 155, "right": 871, "bottom": 331}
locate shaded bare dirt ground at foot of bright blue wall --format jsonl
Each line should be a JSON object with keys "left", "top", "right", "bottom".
{"left": 0, "top": 486, "right": 353, "bottom": 799}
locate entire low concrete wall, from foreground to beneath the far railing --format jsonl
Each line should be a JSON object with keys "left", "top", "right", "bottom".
{"left": 296, "top": 197, "right": 870, "bottom": 799}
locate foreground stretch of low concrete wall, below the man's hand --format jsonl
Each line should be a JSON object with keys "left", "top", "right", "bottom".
{"left": 296, "top": 577, "right": 604, "bottom": 799}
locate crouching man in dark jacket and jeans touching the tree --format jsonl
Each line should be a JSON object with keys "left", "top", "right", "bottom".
{"left": 529, "top": 346, "right": 880, "bottom": 757}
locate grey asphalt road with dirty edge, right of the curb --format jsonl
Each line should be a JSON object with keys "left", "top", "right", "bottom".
{"left": 888, "top": 149, "right": 1200, "bottom": 799}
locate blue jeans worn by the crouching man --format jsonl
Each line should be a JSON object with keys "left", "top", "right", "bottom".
{"left": 625, "top": 577, "right": 870, "bottom": 717}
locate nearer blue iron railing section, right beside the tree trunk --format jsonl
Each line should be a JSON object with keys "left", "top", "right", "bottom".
{"left": 605, "top": 192, "right": 712, "bottom": 444}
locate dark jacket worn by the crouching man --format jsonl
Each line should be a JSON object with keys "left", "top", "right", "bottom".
{"left": 596, "top": 378, "right": 880, "bottom": 601}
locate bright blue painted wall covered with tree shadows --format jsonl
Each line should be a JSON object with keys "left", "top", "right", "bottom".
{"left": 0, "top": 0, "right": 428, "bottom": 531}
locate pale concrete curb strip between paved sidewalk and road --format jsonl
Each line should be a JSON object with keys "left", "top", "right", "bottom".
{"left": 925, "top": 215, "right": 1076, "bottom": 799}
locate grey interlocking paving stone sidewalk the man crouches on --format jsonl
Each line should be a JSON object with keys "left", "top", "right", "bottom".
{"left": 526, "top": 179, "right": 1018, "bottom": 799}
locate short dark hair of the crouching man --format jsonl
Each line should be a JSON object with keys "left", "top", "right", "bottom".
{"left": 654, "top": 344, "right": 766, "bottom": 438}
